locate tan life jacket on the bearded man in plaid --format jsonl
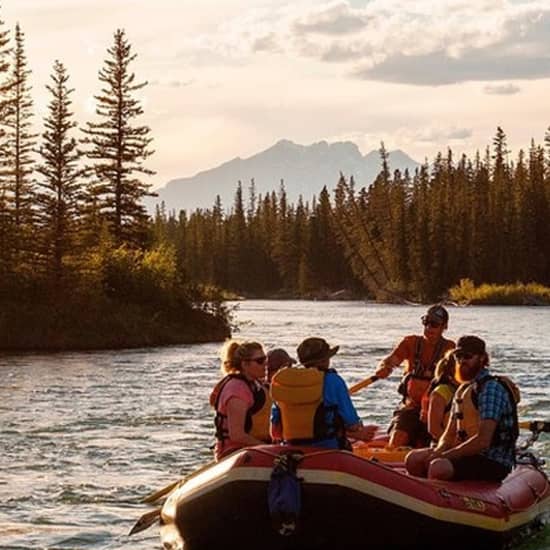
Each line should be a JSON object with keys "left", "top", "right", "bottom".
{"left": 452, "top": 375, "right": 520, "bottom": 454}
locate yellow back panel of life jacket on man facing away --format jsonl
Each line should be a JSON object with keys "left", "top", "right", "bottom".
{"left": 271, "top": 367, "right": 325, "bottom": 441}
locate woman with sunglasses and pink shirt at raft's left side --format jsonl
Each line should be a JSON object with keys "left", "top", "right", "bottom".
{"left": 210, "top": 340, "right": 271, "bottom": 460}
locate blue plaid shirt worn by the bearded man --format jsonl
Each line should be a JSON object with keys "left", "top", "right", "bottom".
{"left": 475, "top": 369, "right": 516, "bottom": 470}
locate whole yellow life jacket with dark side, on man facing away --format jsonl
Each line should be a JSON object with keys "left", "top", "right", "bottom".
{"left": 271, "top": 367, "right": 344, "bottom": 446}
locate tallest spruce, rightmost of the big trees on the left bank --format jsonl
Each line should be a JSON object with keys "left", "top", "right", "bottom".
{"left": 82, "top": 29, "right": 154, "bottom": 247}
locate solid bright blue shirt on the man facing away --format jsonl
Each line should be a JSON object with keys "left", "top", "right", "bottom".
{"left": 271, "top": 369, "right": 361, "bottom": 449}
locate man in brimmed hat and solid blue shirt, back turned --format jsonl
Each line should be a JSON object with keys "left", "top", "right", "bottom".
{"left": 271, "top": 337, "right": 377, "bottom": 449}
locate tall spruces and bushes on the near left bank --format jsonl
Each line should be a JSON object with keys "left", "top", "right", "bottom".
{"left": 0, "top": 14, "right": 229, "bottom": 348}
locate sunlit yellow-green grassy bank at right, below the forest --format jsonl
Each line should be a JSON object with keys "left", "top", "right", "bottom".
{"left": 449, "top": 279, "right": 550, "bottom": 306}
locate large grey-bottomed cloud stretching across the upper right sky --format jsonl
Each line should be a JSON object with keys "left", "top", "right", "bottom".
{"left": 187, "top": 0, "right": 550, "bottom": 86}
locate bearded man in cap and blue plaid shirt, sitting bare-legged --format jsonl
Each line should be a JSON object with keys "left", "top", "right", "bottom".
{"left": 405, "top": 335, "right": 519, "bottom": 481}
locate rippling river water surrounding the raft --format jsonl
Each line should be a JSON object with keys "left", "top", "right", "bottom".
{"left": 0, "top": 300, "right": 550, "bottom": 550}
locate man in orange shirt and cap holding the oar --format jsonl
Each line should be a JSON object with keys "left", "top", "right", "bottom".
{"left": 376, "top": 304, "right": 455, "bottom": 447}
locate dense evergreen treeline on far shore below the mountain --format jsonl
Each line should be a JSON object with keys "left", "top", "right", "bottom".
{"left": 154, "top": 128, "right": 550, "bottom": 302}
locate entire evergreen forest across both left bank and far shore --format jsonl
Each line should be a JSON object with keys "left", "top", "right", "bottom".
{"left": 0, "top": 12, "right": 550, "bottom": 349}
